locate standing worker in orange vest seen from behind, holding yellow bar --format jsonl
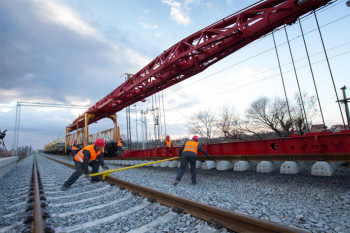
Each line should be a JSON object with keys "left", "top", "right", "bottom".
{"left": 173, "top": 136, "right": 209, "bottom": 186}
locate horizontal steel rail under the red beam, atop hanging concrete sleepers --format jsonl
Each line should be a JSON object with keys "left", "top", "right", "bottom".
{"left": 104, "top": 154, "right": 350, "bottom": 162}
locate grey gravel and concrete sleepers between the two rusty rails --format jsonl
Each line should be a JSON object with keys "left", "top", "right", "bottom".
{"left": 37, "top": 156, "right": 228, "bottom": 233}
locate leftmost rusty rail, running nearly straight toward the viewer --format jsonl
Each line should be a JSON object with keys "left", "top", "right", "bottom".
{"left": 32, "top": 157, "right": 45, "bottom": 233}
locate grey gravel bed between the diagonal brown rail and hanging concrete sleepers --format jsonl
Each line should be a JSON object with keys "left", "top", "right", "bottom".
{"left": 42, "top": 156, "right": 350, "bottom": 232}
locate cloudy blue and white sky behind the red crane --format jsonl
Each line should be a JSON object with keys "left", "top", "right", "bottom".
{"left": 0, "top": 0, "right": 350, "bottom": 149}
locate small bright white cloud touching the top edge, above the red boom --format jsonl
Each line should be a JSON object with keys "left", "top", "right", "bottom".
{"left": 162, "top": 0, "right": 192, "bottom": 26}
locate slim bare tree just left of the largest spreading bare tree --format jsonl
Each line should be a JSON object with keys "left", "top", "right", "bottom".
{"left": 218, "top": 103, "right": 243, "bottom": 141}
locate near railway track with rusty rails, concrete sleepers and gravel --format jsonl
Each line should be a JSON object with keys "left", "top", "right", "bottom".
{"left": 0, "top": 156, "right": 348, "bottom": 232}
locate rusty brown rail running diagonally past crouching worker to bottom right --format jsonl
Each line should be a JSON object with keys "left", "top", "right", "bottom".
{"left": 44, "top": 156, "right": 307, "bottom": 233}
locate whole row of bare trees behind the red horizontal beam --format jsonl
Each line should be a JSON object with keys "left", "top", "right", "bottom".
{"left": 188, "top": 92, "right": 318, "bottom": 143}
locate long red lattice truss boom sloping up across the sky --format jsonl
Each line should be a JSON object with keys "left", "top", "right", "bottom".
{"left": 67, "top": 0, "right": 331, "bottom": 131}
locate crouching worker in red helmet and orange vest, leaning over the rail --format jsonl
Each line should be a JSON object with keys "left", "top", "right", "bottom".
{"left": 61, "top": 139, "right": 108, "bottom": 191}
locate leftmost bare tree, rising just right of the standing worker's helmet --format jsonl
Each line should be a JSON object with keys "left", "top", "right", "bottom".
{"left": 188, "top": 109, "right": 218, "bottom": 143}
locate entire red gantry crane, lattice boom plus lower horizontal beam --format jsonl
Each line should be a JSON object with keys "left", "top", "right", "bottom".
{"left": 66, "top": 0, "right": 350, "bottom": 167}
